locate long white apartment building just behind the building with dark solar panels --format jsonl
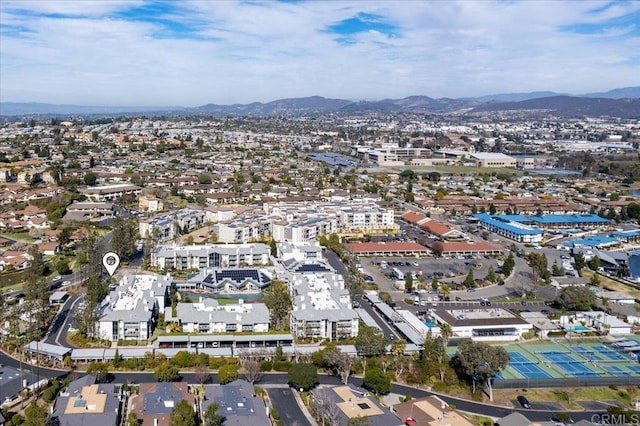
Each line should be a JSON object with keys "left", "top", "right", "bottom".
{"left": 151, "top": 243, "right": 271, "bottom": 270}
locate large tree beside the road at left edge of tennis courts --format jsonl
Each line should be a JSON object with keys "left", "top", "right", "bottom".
{"left": 453, "top": 339, "right": 509, "bottom": 401}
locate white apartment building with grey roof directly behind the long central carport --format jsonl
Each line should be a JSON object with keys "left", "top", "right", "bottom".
{"left": 164, "top": 298, "right": 270, "bottom": 333}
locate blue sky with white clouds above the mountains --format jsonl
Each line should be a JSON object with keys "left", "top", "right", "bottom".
{"left": 0, "top": 0, "right": 640, "bottom": 107}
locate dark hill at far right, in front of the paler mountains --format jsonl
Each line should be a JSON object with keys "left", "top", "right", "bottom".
{"left": 470, "top": 96, "right": 640, "bottom": 118}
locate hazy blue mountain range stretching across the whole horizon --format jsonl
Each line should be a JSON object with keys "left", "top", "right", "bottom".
{"left": 0, "top": 86, "right": 640, "bottom": 118}
